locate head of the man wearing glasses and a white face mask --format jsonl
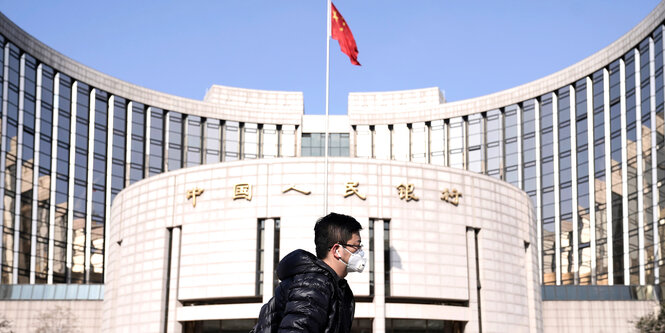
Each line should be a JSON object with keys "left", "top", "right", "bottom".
{"left": 314, "top": 213, "right": 366, "bottom": 277}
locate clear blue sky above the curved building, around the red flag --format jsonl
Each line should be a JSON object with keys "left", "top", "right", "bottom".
{"left": 0, "top": 0, "right": 658, "bottom": 114}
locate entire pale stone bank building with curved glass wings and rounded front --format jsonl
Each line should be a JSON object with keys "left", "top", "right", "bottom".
{"left": 0, "top": 3, "right": 665, "bottom": 333}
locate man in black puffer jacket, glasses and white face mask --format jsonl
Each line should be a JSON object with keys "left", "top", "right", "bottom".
{"left": 254, "top": 213, "right": 367, "bottom": 333}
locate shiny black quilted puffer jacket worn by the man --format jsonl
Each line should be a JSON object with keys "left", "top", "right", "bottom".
{"left": 254, "top": 250, "right": 355, "bottom": 333}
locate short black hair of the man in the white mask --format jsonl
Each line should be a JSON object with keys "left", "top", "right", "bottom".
{"left": 314, "top": 213, "right": 363, "bottom": 259}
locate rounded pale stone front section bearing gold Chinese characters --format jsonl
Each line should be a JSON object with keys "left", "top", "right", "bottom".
{"left": 103, "top": 158, "right": 542, "bottom": 332}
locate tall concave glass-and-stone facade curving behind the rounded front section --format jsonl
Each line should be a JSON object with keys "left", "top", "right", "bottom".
{"left": 0, "top": 3, "right": 665, "bottom": 331}
